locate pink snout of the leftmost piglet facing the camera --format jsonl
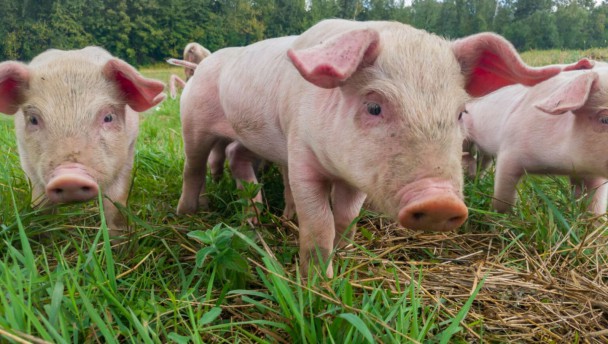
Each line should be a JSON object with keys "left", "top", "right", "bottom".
{"left": 45, "top": 164, "right": 99, "bottom": 203}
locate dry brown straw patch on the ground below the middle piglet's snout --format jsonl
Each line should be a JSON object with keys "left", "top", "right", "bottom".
{"left": 318, "top": 214, "right": 608, "bottom": 343}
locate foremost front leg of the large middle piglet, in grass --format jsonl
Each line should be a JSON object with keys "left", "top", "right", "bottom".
{"left": 289, "top": 152, "right": 335, "bottom": 277}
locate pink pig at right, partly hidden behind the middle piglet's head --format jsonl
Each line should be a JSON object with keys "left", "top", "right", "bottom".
{"left": 463, "top": 63, "right": 608, "bottom": 215}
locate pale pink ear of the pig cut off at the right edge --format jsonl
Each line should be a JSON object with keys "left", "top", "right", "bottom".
{"left": 535, "top": 72, "right": 598, "bottom": 115}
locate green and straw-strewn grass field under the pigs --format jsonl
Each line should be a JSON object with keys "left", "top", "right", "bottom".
{"left": 0, "top": 52, "right": 608, "bottom": 343}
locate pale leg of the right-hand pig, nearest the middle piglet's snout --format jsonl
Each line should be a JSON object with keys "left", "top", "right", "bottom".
{"left": 492, "top": 155, "right": 523, "bottom": 213}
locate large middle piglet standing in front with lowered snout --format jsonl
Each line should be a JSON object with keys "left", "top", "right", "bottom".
{"left": 177, "top": 19, "right": 576, "bottom": 276}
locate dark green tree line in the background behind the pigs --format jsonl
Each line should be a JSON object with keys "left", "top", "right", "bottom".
{"left": 0, "top": 0, "right": 608, "bottom": 65}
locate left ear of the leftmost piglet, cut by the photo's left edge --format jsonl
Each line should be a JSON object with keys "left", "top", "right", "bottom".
{"left": 0, "top": 61, "right": 30, "bottom": 115}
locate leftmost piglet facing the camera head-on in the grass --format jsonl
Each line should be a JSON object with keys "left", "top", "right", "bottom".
{"left": 0, "top": 47, "right": 165, "bottom": 236}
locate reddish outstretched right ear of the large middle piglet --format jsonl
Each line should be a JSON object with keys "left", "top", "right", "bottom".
{"left": 452, "top": 33, "right": 561, "bottom": 97}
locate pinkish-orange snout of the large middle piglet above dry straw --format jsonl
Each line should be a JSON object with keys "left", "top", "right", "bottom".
{"left": 398, "top": 180, "right": 468, "bottom": 231}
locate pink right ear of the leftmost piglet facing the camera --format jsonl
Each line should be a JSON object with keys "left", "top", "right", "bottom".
{"left": 103, "top": 59, "right": 165, "bottom": 112}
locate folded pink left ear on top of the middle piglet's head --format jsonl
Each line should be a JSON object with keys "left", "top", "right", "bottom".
{"left": 287, "top": 29, "right": 380, "bottom": 88}
